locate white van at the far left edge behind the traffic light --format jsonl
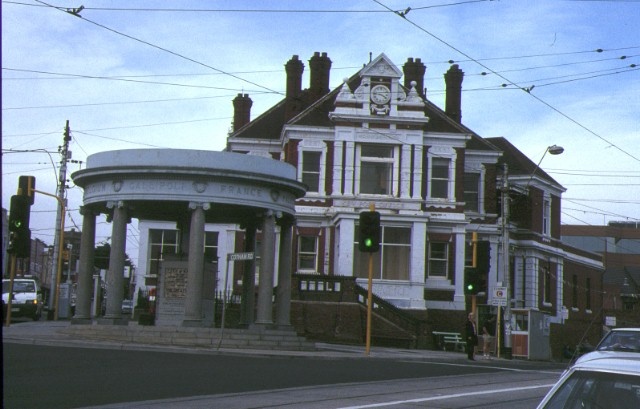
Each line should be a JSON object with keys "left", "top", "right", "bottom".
{"left": 2, "top": 278, "right": 42, "bottom": 321}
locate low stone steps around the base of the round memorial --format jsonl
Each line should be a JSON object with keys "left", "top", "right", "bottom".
{"left": 60, "top": 322, "right": 316, "bottom": 351}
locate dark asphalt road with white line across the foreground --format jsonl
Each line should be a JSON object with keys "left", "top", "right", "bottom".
{"left": 3, "top": 343, "right": 561, "bottom": 409}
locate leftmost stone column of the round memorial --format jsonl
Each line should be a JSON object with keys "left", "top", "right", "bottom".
{"left": 71, "top": 206, "right": 96, "bottom": 324}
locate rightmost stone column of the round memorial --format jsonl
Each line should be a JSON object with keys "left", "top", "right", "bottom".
{"left": 276, "top": 219, "right": 293, "bottom": 327}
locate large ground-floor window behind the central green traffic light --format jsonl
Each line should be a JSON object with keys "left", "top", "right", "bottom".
{"left": 354, "top": 226, "right": 411, "bottom": 280}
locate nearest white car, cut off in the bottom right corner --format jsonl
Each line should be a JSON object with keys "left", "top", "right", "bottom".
{"left": 538, "top": 352, "right": 640, "bottom": 409}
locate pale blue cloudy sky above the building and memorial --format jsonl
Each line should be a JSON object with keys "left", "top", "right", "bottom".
{"left": 2, "top": 0, "right": 640, "bottom": 266}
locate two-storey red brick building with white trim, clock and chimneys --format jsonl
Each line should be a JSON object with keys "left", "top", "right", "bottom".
{"left": 131, "top": 53, "right": 603, "bottom": 357}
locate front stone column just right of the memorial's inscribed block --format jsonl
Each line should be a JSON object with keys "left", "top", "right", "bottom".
{"left": 182, "top": 203, "right": 209, "bottom": 327}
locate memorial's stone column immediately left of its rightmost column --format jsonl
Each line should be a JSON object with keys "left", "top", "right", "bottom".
{"left": 256, "top": 211, "right": 276, "bottom": 325}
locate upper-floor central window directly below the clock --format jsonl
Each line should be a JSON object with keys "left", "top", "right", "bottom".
{"left": 356, "top": 145, "right": 399, "bottom": 196}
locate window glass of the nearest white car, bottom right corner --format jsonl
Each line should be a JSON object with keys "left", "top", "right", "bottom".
{"left": 544, "top": 370, "right": 640, "bottom": 409}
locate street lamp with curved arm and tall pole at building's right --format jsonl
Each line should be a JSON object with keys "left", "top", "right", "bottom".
{"left": 501, "top": 145, "right": 564, "bottom": 357}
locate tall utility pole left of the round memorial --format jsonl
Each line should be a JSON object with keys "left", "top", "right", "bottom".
{"left": 49, "top": 119, "right": 71, "bottom": 319}
